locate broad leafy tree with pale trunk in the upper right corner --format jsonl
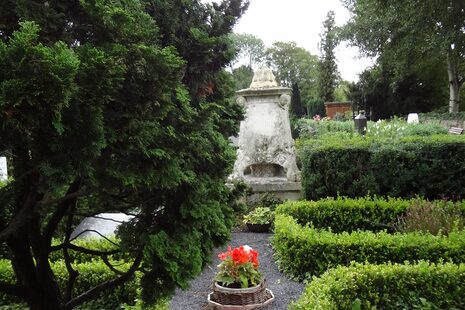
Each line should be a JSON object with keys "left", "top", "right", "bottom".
{"left": 342, "top": 0, "right": 465, "bottom": 113}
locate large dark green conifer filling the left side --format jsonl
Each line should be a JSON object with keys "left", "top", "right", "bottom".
{"left": 0, "top": 0, "right": 247, "bottom": 309}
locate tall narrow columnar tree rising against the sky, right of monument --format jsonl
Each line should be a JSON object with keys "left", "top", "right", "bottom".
{"left": 318, "top": 11, "right": 338, "bottom": 102}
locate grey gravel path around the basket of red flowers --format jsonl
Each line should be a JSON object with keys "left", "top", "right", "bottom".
{"left": 170, "top": 232, "right": 305, "bottom": 310}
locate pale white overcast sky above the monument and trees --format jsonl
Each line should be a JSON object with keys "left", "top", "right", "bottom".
{"left": 205, "top": 0, "right": 372, "bottom": 81}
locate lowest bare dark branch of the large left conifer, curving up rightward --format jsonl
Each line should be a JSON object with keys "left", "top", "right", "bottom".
{"left": 65, "top": 250, "right": 143, "bottom": 309}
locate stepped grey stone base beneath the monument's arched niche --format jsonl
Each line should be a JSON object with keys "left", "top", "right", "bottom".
{"left": 244, "top": 178, "right": 302, "bottom": 201}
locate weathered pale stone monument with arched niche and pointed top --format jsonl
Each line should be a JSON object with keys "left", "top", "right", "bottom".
{"left": 230, "top": 67, "right": 301, "bottom": 199}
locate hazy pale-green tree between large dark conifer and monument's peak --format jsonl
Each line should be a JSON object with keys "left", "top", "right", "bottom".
{"left": 230, "top": 33, "right": 265, "bottom": 68}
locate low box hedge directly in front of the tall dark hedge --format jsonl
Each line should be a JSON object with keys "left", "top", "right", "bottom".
{"left": 276, "top": 196, "right": 465, "bottom": 234}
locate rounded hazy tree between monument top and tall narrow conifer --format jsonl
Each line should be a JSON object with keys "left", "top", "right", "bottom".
{"left": 266, "top": 42, "right": 318, "bottom": 102}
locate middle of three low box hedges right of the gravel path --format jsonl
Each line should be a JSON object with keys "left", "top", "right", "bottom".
{"left": 273, "top": 215, "right": 465, "bottom": 279}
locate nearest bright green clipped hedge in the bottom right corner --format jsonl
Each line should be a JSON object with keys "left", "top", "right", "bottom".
{"left": 289, "top": 262, "right": 465, "bottom": 310}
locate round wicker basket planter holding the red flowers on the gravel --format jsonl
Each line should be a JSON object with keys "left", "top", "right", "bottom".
{"left": 208, "top": 281, "right": 274, "bottom": 310}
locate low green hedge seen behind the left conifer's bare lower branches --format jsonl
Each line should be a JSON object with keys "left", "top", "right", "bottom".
{"left": 0, "top": 260, "right": 140, "bottom": 309}
